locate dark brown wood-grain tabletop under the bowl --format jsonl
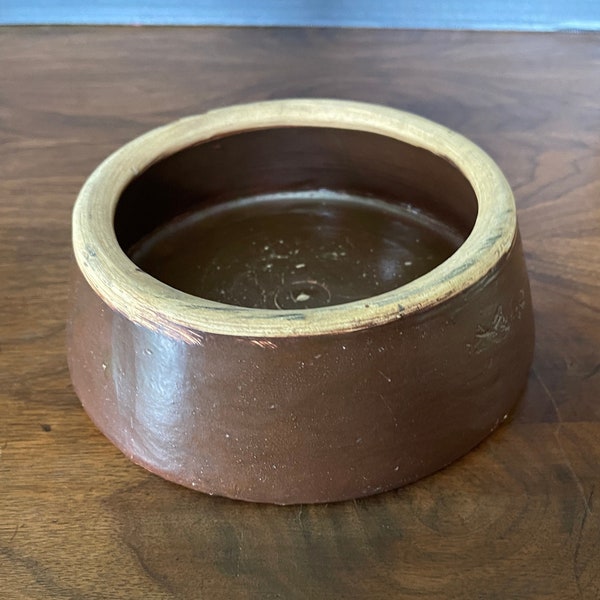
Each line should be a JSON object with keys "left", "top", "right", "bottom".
{"left": 0, "top": 28, "right": 600, "bottom": 600}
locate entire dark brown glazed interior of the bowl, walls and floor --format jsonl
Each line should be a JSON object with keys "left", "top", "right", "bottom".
{"left": 114, "top": 127, "right": 477, "bottom": 309}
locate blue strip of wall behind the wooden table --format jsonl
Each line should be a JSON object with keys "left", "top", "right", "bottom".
{"left": 0, "top": 0, "right": 600, "bottom": 31}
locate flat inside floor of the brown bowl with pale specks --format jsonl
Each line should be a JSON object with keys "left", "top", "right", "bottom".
{"left": 129, "top": 190, "right": 464, "bottom": 310}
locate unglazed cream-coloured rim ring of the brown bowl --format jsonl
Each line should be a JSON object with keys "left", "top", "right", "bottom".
{"left": 73, "top": 99, "right": 516, "bottom": 343}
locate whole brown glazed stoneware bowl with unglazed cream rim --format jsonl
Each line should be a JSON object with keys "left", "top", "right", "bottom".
{"left": 69, "top": 100, "right": 533, "bottom": 504}
